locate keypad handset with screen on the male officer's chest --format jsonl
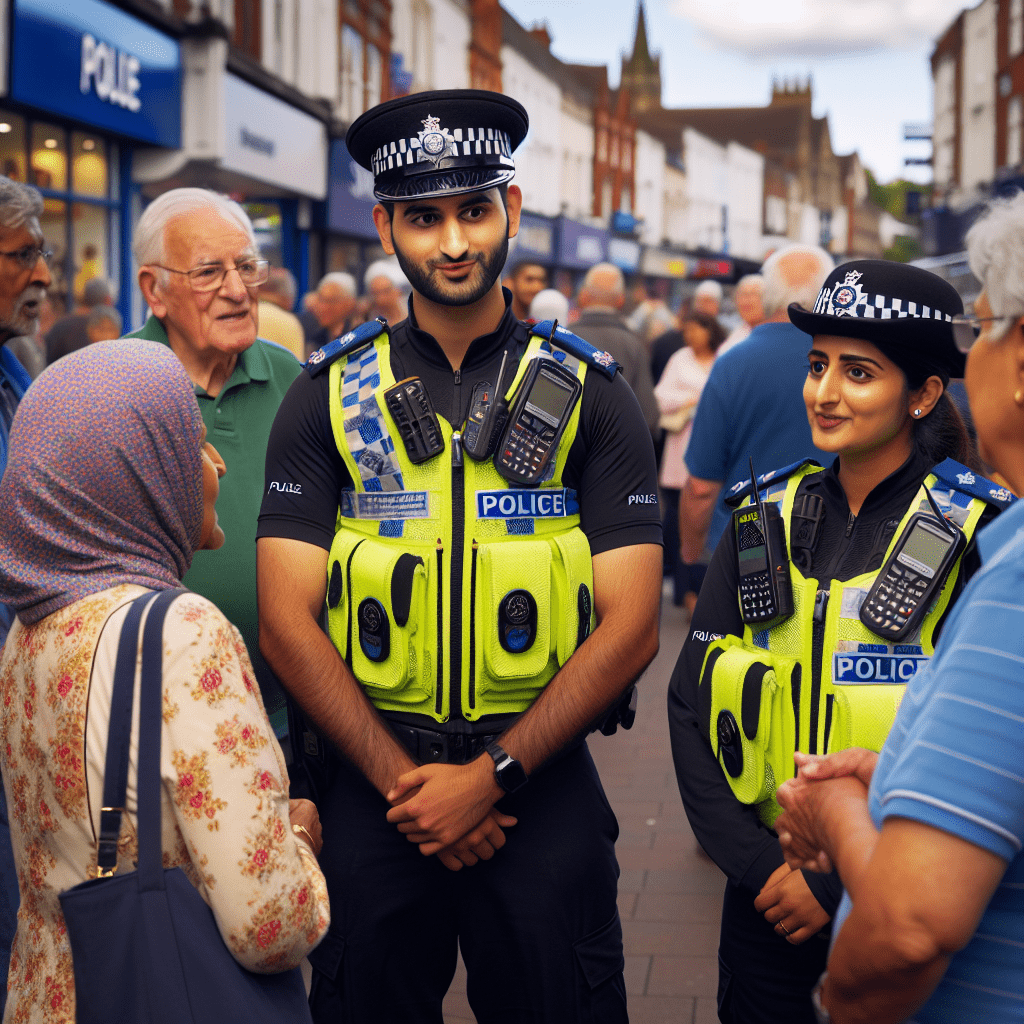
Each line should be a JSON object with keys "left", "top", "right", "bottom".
{"left": 495, "top": 358, "right": 583, "bottom": 486}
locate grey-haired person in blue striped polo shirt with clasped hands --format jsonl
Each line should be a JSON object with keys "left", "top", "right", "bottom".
{"left": 778, "top": 194, "right": 1024, "bottom": 1024}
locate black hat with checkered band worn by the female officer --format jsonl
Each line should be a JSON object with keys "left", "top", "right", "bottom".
{"left": 790, "top": 259, "right": 964, "bottom": 380}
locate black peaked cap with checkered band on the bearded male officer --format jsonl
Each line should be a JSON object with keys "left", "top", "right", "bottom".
{"left": 345, "top": 89, "right": 529, "bottom": 202}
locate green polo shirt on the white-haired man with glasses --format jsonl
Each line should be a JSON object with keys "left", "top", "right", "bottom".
{"left": 128, "top": 316, "right": 302, "bottom": 735}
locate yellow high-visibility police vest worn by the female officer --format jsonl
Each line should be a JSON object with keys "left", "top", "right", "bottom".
{"left": 698, "top": 460, "right": 1006, "bottom": 825}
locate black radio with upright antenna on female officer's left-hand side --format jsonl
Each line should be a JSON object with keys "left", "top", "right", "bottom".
{"left": 732, "top": 459, "right": 793, "bottom": 625}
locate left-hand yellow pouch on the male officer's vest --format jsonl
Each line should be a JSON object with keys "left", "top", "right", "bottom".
{"left": 346, "top": 538, "right": 436, "bottom": 705}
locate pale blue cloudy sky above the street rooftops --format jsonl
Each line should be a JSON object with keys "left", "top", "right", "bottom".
{"left": 503, "top": 0, "right": 969, "bottom": 181}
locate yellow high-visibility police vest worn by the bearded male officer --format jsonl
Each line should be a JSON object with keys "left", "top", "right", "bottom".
{"left": 328, "top": 327, "right": 598, "bottom": 722}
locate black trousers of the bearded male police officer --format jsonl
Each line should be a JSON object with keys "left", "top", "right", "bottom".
{"left": 309, "top": 745, "right": 629, "bottom": 1024}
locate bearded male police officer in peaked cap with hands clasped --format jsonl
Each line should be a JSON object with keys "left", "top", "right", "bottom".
{"left": 258, "top": 90, "right": 660, "bottom": 1024}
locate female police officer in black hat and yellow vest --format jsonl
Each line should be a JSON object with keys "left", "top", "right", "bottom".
{"left": 669, "top": 260, "right": 999, "bottom": 1024}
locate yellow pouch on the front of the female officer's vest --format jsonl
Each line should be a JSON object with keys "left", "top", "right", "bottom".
{"left": 698, "top": 636, "right": 800, "bottom": 817}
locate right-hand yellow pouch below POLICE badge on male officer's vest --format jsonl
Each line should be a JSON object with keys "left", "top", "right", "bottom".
{"left": 473, "top": 540, "right": 554, "bottom": 700}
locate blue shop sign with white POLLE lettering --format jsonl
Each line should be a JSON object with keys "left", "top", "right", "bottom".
{"left": 10, "top": 0, "right": 181, "bottom": 148}
